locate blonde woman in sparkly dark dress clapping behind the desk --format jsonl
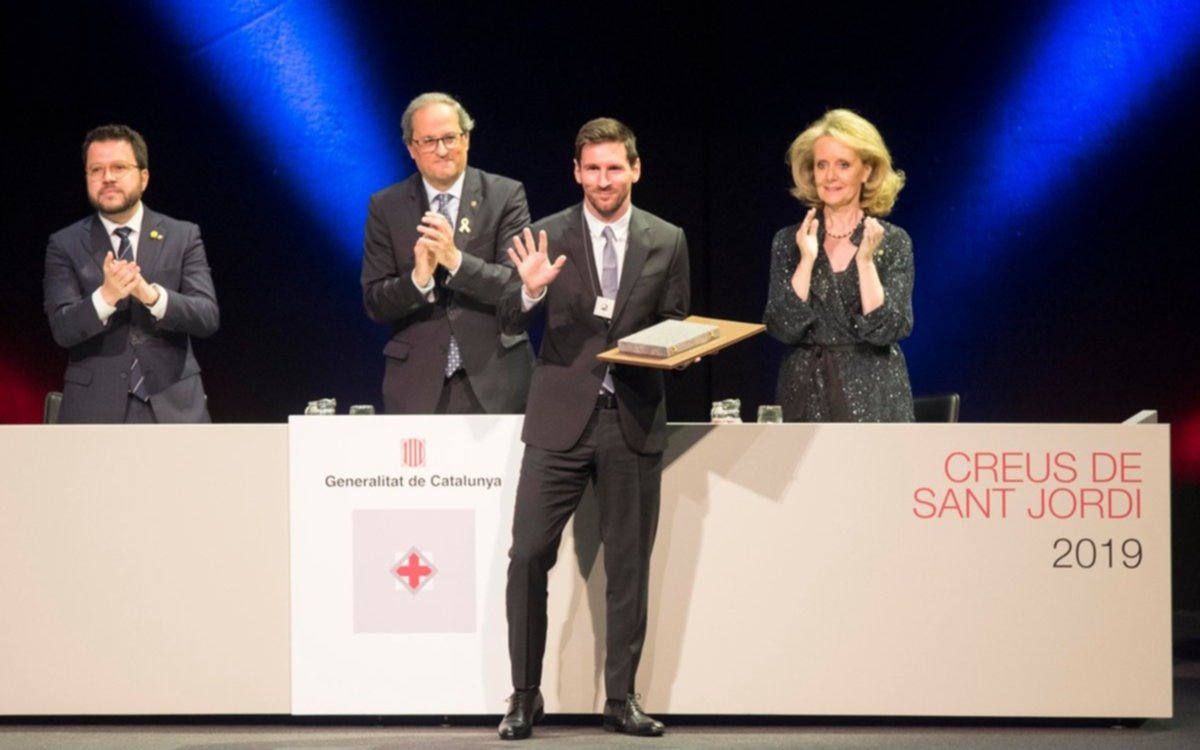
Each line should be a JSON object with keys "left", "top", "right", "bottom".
{"left": 763, "top": 109, "right": 913, "bottom": 422}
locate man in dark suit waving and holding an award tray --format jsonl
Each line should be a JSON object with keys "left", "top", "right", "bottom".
{"left": 499, "top": 118, "right": 690, "bottom": 739}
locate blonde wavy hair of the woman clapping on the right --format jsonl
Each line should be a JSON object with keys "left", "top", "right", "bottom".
{"left": 786, "top": 109, "right": 905, "bottom": 216}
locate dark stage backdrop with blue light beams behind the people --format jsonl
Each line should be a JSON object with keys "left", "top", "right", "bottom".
{"left": 0, "top": 0, "right": 1200, "bottom": 598}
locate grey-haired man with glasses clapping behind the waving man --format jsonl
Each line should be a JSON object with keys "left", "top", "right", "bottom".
{"left": 362, "top": 92, "right": 533, "bottom": 414}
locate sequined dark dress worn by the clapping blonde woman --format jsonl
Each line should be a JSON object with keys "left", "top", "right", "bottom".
{"left": 763, "top": 220, "right": 913, "bottom": 422}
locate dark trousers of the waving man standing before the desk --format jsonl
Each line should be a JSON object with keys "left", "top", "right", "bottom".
{"left": 506, "top": 408, "right": 662, "bottom": 700}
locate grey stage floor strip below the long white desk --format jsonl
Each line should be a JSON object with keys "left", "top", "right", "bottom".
{"left": 0, "top": 641, "right": 1200, "bottom": 750}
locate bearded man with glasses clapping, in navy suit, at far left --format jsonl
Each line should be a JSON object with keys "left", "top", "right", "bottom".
{"left": 43, "top": 125, "right": 220, "bottom": 422}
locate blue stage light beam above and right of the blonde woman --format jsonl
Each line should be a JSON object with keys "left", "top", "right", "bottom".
{"left": 905, "top": 0, "right": 1200, "bottom": 374}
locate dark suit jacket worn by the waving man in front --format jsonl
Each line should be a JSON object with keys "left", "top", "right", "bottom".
{"left": 500, "top": 204, "right": 690, "bottom": 454}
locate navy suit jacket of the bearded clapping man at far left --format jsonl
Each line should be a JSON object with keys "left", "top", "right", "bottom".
{"left": 42, "top": 208, "right": 220, "bottom": 422}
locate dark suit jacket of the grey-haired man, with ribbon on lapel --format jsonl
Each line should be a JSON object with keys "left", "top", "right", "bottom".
{"left": 362, "top": 167, "right": 533, "bottom": 414}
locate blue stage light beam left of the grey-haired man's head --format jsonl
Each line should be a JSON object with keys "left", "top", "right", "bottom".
{"left": 152, "top": 0, "right": 406, "bottom": 263}
